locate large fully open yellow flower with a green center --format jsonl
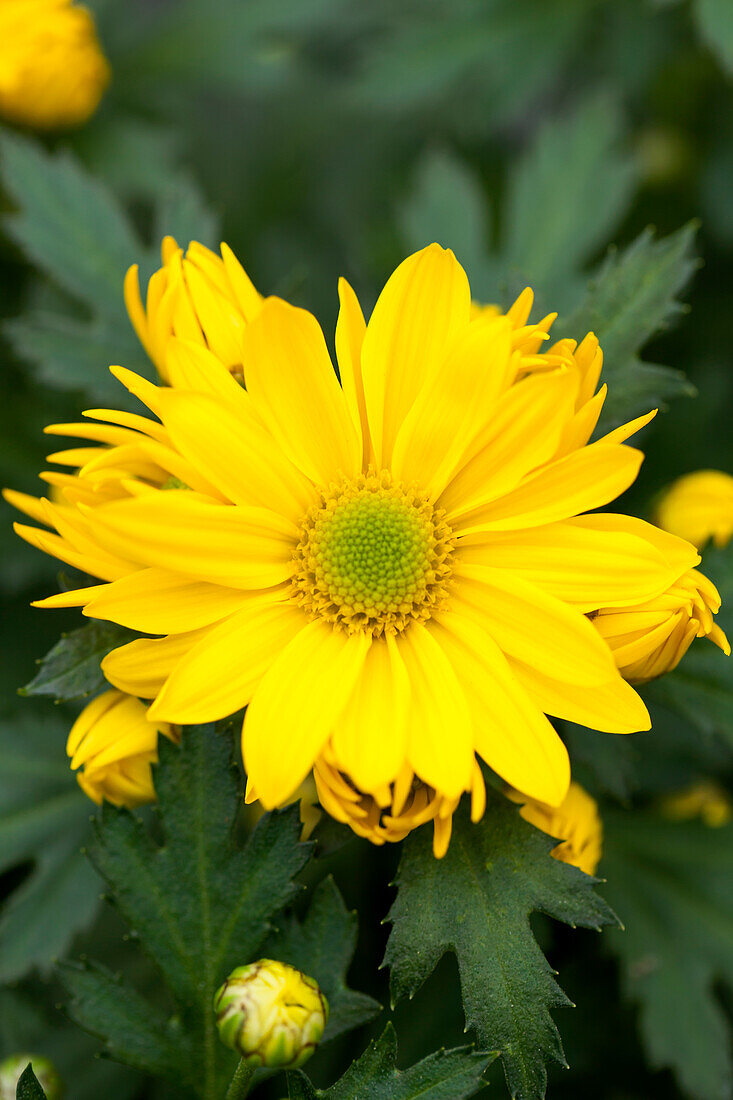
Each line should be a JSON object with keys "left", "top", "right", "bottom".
{"left": 9, "top": 245, "right": 717, "bottom": 848}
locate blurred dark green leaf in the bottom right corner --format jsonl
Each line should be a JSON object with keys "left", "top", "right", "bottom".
{"left": 602, "top": 812, "right": 733, "bottom": 1100}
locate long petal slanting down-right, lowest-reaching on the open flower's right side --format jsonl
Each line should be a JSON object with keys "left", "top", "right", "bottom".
{"left": 430, "top": 612, "right": 570, "bottom": 805}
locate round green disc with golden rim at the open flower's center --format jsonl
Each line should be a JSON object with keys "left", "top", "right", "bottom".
{"left": 294, "top": 471, "right": 452, "bottom": 635}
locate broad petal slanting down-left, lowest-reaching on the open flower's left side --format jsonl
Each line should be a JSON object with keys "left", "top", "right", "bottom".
{"left": 242, "top": 620, "right": 371, "bottom": 810}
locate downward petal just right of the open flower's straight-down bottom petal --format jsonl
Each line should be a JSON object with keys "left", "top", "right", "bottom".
{"left": 397, "top": 624, "right": 474, "bottom": 799}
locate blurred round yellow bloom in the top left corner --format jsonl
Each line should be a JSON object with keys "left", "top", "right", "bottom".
{"left": 0, "top": 0, "right": 110, "bottom": 130}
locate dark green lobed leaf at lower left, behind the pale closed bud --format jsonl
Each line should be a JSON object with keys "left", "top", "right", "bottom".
{"left": 65, "top": 726, "right": 309, "bottom": 1097}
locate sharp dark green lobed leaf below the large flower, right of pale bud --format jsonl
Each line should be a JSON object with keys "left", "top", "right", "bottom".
{"left": 385, "top": 794, "right": 615, "bottom": 1100}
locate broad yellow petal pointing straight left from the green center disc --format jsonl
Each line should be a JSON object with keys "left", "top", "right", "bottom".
{"left": 81, "top": 490, "right": 297, "bottom": 589}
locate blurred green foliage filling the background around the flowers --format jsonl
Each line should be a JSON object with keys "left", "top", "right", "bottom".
{"left": 0, "top": 0, "right": 733, "bottom": 1100}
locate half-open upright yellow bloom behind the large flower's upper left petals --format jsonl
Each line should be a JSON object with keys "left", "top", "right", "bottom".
{"left": 124, "top": 237, "right": 262, "bottom": 383}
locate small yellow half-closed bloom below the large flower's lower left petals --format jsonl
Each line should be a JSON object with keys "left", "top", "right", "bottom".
{"left": 66, "top": 691, "right": 177, "bottom": 807}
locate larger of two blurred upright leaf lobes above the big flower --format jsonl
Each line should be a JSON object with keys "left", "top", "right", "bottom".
{"left": 502, "top": 96, "right": 635, "bottom": 308}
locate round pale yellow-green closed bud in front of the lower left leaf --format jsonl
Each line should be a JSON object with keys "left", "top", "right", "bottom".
{"left": 214, "top": 959, "right": 328, "bottom": 1069}
